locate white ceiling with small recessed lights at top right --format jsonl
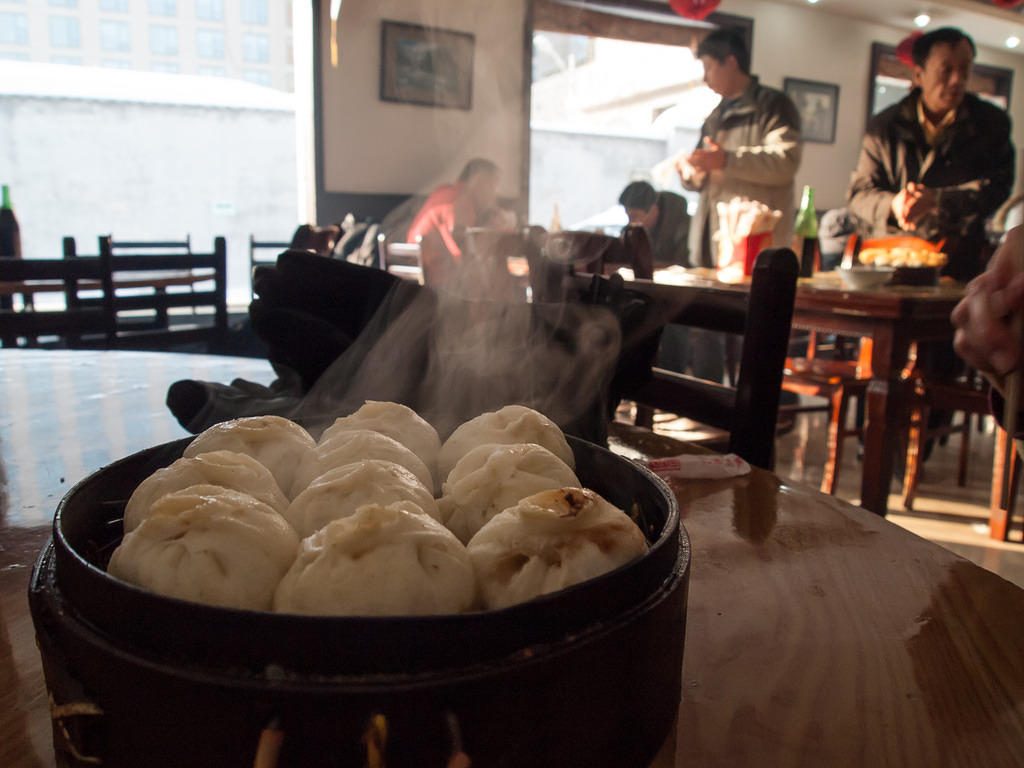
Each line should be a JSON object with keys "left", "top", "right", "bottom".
{"left": 770, "top": 0, "right": 1024, "bottom": 55}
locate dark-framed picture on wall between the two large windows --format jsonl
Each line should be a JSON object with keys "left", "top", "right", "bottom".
{"left": 381, "top": 22, "right": 475, "bottom": 110}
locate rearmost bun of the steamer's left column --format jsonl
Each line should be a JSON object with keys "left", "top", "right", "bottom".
{"left": 184, "top": 416, "right": 316, "bottom": 494}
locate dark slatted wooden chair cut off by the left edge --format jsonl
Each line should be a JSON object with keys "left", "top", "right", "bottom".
{"left": 0, "top": 257, "right": 113, "bottom": 347}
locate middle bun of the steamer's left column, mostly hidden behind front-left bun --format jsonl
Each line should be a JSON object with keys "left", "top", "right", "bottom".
{"left": 124, "top": 451, "right": 288, "bottom": 532}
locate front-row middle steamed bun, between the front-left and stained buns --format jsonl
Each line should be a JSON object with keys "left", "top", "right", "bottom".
{"left": 273, "top": 502, "right": 476, "bottom": 615}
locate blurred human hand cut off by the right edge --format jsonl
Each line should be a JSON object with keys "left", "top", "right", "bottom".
{"left": 950, "top": 226, "right": 1024, "bottom": 388}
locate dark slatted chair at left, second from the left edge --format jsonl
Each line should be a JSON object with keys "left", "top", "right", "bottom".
{"left": 99, "top": 236, "right": 227, "bottom": 350}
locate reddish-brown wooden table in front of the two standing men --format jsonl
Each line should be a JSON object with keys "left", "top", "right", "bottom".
{"left": 654, "top": 268, "right": 964, "bottom": 515}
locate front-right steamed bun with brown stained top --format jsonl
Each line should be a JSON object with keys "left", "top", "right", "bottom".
{"left": 467, "top": 488, "right": 647, "bottom": 608}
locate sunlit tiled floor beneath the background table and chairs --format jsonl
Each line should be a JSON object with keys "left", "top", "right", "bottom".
{"left": 656, "top": 413, "right": 1024, "bottom": 588}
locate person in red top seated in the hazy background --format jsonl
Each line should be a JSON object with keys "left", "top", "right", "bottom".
{"left": 407, "top": 158, "right": 501, "bottom": 285}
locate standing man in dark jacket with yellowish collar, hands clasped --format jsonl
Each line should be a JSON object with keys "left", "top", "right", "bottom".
{"left": 849, "top": 27, "right": 1014, "bottom": 282}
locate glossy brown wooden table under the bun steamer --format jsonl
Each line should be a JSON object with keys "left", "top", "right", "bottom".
{"left": 0, "top": 349, "right": 1024, "bottom": 768}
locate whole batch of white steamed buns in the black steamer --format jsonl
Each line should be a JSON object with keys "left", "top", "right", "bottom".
{"left": 110, "top": 402, "right": 647, "bottom": 615}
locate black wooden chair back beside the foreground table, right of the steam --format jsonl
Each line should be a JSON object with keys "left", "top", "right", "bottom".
{"left": 593, "top": 248, "right": 799, "bottom": 469}
